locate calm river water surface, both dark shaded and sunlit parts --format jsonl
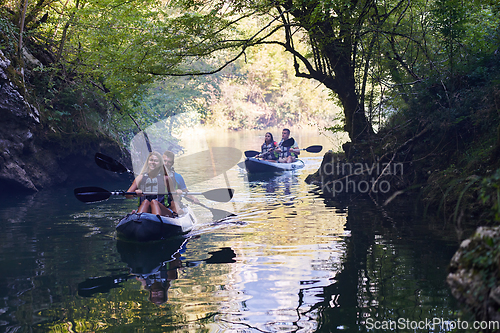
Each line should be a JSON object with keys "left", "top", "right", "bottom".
{"left": 0, "top": 127, "right": 474, "bottom": 332}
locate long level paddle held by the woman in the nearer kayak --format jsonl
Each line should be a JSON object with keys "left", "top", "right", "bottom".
{"left": 74, "top": 186, "right": 234, "bottom": 202}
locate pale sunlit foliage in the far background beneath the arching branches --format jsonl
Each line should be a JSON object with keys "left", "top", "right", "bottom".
{"left": 125, "top": 37, "right": 338, "bottom": 129}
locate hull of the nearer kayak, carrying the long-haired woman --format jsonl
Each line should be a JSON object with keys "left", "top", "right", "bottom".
{"left": 116, "top": 206, "right": 197, "bottom": 242}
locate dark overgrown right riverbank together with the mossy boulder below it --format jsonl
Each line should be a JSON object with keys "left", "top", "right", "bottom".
{"left": 306, "top": 54, "right": 500, "bottom": 320}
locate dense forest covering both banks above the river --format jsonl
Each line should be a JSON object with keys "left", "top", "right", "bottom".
{"left": 0, "top": 0, "right": 500, "bottom": 317}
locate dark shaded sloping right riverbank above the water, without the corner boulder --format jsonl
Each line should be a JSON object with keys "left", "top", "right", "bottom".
{"left": 307, "top": 51, "right": 500, "bottom": 224}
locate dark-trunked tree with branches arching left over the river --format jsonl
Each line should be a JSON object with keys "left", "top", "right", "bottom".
{"left": 88, "top": 0, "right": 432, "bottom": 142}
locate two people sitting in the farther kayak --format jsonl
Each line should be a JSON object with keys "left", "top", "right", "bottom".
{"left": 259, "top": 128, "right": 300, "bottom": 163}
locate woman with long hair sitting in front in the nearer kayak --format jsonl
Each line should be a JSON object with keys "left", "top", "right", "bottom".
{"left": 126, "top": 152, "right": 182, "bottom": 217}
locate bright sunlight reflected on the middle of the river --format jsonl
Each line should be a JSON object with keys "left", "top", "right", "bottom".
{"left": 148, "top": 126, "right": 349, "bottom": 331}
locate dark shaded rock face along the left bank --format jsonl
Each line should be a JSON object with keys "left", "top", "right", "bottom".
{"left": 0, "top": 51, "right": 126, "bottom": 192}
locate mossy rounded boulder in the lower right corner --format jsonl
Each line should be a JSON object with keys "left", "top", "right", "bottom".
{"left": 446, "top": 227, "right": 500, "bottom": 321}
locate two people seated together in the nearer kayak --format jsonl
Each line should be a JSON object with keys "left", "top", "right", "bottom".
{"left": 126, "top": 150, "right": 200, "bottom": 217}
